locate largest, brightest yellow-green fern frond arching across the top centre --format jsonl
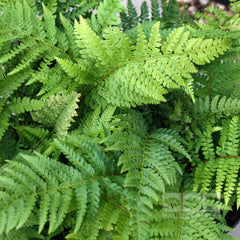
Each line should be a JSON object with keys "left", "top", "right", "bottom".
{"left": 69, "top": 19, "right": 231, "bottom": 107}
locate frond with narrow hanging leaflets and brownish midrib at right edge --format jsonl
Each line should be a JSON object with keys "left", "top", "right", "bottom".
{"left": 195, "top": 116, "right": 240, "bottom": 204}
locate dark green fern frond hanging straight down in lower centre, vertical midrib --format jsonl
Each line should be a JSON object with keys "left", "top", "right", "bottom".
{"left": 104, "top": 112, "right": 186, "bottom": 239}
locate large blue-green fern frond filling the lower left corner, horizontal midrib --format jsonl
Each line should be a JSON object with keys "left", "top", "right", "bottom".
{"left": 0, "top": 137, "right": 122, "bottom": 233}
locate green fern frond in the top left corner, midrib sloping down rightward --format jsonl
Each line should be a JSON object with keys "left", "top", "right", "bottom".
{"left": 0, "top": 0, "right": 77, "bottom": 94}
